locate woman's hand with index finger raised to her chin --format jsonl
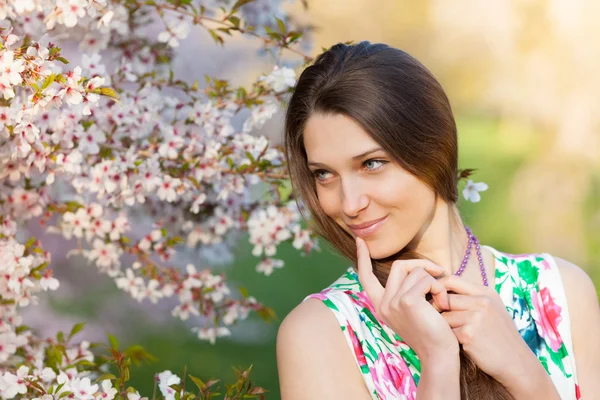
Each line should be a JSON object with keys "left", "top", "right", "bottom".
{"left": 356, "top": 237, "right": 458, "bottom": 363}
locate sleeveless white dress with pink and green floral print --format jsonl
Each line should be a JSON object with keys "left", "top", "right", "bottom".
{"left": 305, "top": 246, "right": 580, "bottom": 400}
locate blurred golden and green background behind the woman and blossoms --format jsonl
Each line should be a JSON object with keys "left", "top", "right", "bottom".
{"left": 26, "top": 0, "right": 600, "bottom": 399}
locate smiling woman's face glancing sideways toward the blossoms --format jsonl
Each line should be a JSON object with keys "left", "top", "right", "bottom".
{"left": 304, "top": 114, "right": 436, "bottom": 259}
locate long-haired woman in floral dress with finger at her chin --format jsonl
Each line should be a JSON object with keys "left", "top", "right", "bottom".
{"left": 277, "top": 42, "right": 600, "bottom": 400}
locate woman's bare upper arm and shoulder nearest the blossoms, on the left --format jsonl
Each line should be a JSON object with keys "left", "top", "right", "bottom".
{"left": 277, "top": 299, "right": 371, "bottom": 400}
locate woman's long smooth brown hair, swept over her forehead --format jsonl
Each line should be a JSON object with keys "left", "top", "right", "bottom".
{"left": 284, "top": 41, "right": 513, "bottom": 400}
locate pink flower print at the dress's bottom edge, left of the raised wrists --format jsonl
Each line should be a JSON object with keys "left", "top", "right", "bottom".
{"left": 370, "top": 353, "right": 417, "bottom": 400}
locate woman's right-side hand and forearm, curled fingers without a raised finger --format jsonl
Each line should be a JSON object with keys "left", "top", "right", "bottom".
{"left": 438, "top": 275, "right": 552, "bottom": 393}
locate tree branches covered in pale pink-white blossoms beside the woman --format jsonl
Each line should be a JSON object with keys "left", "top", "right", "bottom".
{"left": 0, "top": 0, "right": 316, "bottom": 400}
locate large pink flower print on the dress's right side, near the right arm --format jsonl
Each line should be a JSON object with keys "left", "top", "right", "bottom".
{"left": 531, "top": 288, "right": 562, "bottom": 351}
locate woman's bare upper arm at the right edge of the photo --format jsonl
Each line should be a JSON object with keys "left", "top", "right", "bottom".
{"left": 555, "top": 257, "right": 600, "bottom": 399}
